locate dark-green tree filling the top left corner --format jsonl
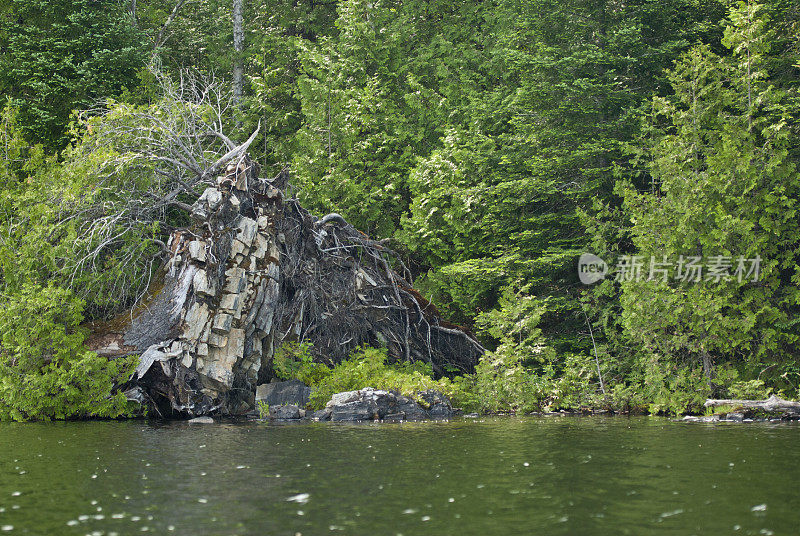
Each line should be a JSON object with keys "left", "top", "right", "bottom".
{"left": 0, "top": 0, "right": 145, "bottom": 151}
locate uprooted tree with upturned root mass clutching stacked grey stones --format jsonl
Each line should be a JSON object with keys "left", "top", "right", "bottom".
{"left": 78, "top": 72, "right": 483, "bottom": 415}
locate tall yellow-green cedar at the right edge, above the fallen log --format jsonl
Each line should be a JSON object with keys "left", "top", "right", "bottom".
{"left": 621, "top": 4, "right": 800, "bottom": 406}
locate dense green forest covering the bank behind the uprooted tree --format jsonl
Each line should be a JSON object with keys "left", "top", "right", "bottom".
{"left": 0, "top": 0, "right": 800, "bottom": 419}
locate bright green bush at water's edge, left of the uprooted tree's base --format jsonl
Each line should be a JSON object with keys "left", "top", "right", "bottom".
{"left": 0, "top": 284, "right": 135, "bottom": 421}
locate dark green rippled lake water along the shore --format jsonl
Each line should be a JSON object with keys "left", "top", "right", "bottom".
{"left": 0, "top": 417, "right": 800, "bottom": 536}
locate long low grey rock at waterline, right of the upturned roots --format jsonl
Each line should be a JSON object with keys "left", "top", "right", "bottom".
{"left": 324, "top": 387, "right": 453, "bottom": 422}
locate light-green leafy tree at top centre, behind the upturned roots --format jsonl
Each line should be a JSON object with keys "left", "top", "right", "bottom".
{"left": 294, "top": 0, "right": 491, "bottom": 237}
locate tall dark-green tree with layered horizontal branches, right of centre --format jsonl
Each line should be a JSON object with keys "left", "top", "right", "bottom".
{"left": 399, "top": 0, "right": 723, "bottom": 344}
